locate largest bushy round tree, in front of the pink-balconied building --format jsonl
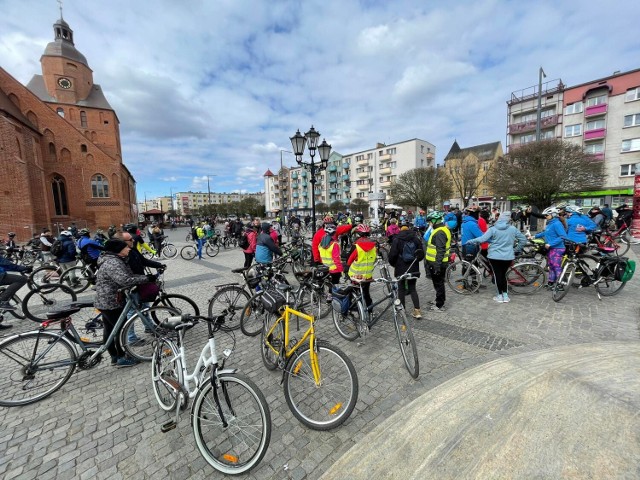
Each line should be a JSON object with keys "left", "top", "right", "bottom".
{"left": 489, "top": 139, "right": 605, "bottom": 208}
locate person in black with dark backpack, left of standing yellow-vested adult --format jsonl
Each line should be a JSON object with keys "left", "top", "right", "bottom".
{"left": 389, "top": 224, "right": 426, "bottom": 318}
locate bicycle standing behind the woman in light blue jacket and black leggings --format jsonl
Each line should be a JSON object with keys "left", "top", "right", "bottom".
{"left": 445, "top": 251, "right": 545, "bottom": 295}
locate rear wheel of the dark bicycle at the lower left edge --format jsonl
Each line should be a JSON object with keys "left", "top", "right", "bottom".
{"left": 0, "top": 332, "right": 77, "bottom": 407}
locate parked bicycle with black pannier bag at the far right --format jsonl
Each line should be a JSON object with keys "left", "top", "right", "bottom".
{"left": 551, "top": 240, "right": 627, "bottom": 302}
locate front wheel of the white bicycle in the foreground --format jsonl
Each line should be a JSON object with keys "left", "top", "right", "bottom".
{"left": 191, "top": 373, "right": 271, "bottom": 475}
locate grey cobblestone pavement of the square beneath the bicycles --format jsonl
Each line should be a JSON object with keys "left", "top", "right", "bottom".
{"left": 0, "top": 229, "right": 640, "bottom": 480}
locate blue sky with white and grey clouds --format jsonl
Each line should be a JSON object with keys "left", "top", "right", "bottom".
{"left": 0, "top": 0, "right": 640, "bottom": 198}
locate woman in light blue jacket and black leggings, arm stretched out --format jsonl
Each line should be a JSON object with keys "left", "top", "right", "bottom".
{"left": 463, "top": 211, "right": 527, "bottom": 303}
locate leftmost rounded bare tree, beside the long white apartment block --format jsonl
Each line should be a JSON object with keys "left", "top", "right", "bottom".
{"left": 390, "top": 167, "right": 451, "bottom": 210}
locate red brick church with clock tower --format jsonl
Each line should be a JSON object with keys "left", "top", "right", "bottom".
{"left": 0, "top": 14, "right": 137, "bottom": 242}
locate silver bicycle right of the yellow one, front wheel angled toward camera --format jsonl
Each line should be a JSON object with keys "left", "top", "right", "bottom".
{"left": 332, "top": 253, "right": 424, "bottom": 379}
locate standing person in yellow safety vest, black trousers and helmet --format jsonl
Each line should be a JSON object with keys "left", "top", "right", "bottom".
{"left": 425, "top": 212, "right": 451, "bottom": 312}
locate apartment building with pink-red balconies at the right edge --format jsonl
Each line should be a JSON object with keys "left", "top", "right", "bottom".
{"left": 507, "top": 69, "right": 640, "bottom": 207}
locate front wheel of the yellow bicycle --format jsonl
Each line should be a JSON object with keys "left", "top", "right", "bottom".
{"left": 284, "top": 341, "right": 358, "bottom": 430}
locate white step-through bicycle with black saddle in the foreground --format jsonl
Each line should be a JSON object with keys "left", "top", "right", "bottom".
{"left": 151, "top": 315, "right": 271, "bottom": 475}
